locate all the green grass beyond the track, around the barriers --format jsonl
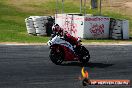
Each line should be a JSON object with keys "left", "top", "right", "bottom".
{"left": 0, "top": 0, "right": 132, "bottom": 43}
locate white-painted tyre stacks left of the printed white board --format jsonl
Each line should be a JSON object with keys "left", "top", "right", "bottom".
{"left": 25, "top": 16, "right": 53, "bottom": 36}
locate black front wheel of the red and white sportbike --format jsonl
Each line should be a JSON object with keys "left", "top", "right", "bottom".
{"left": 49, "top": 49, "right": 64, "bottom": 65}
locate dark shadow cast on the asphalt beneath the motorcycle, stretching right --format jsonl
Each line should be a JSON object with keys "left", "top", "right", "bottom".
{"left": 61, "top": 62, "right": 114, "bottom": 68}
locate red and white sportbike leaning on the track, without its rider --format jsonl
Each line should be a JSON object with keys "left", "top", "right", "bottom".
{"left": 47, "top": 35, "right": 90, "bottom": 65}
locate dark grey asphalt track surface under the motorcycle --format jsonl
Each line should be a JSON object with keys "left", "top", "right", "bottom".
{"left": 0, "top": 45, "right": 132, "bottom": 88}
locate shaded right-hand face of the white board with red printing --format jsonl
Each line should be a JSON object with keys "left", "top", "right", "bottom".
{"left": 83, "top": 16, "right": 110, "bottom": 38}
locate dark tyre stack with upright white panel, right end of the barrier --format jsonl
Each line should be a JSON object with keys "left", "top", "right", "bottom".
{"left": 110, "top": 19, "right": 129, "bottom": 39}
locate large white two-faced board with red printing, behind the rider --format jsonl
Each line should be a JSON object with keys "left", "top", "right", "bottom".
{"left": 55, "top": 14, "right": 110, "bottom": 38}
